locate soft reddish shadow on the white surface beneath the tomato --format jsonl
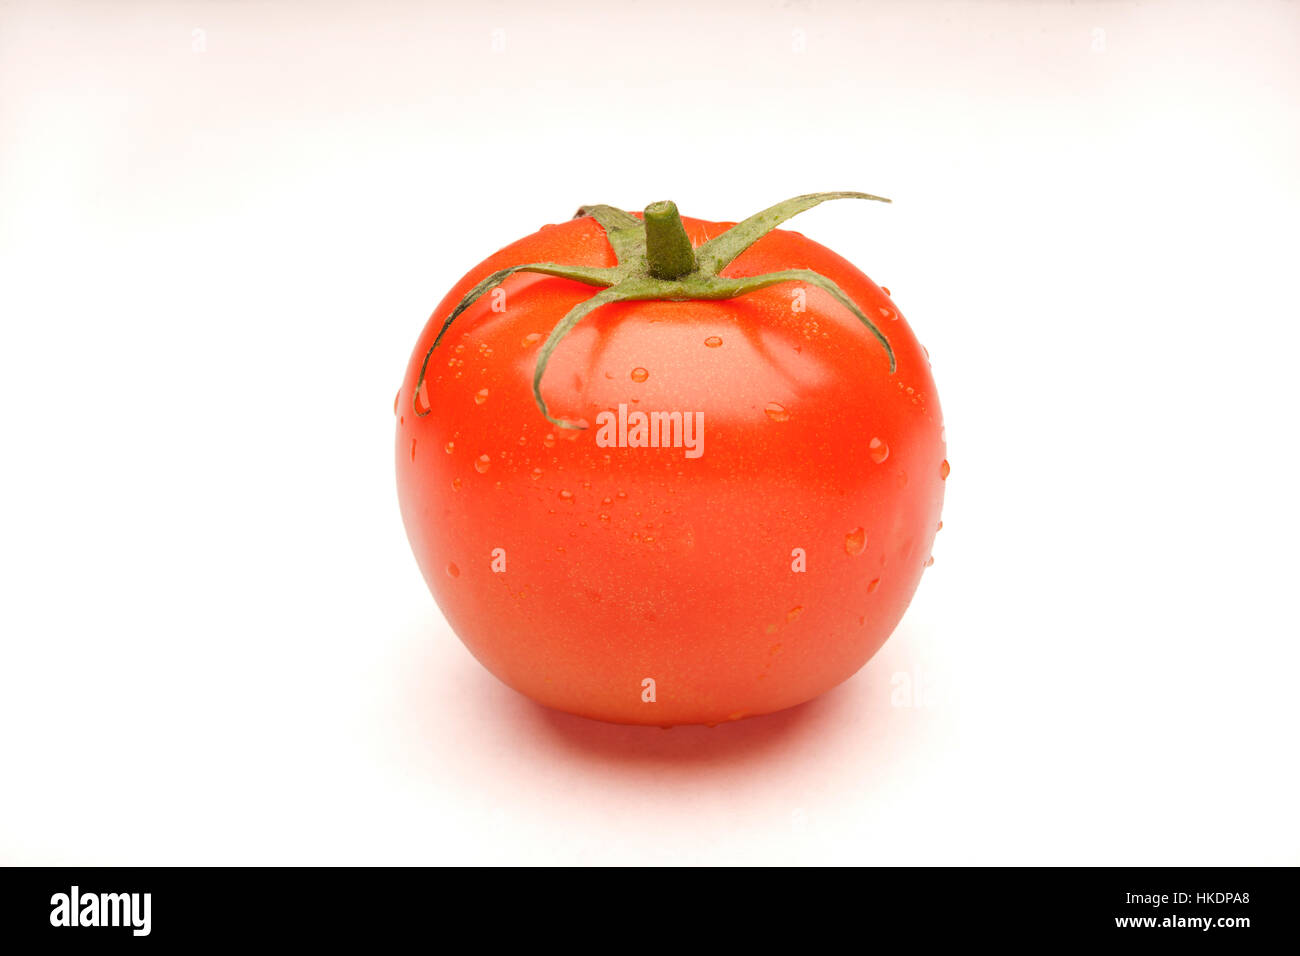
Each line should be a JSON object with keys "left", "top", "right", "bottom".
{"left": 400, "top": 606, "right": 928, "bottom": 786}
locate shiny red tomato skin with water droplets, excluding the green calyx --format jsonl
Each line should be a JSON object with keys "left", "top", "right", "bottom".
{"left": 397, "top": 219, "right": 945, "bottom": 726}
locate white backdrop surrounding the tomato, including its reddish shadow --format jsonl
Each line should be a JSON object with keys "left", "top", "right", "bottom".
{"left": 0, "top": 0, "right": 1300, "bottom": 864}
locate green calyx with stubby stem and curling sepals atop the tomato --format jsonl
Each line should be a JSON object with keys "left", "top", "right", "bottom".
{"left": 411, "top": 193, "right": 897, "bottom": 429}
